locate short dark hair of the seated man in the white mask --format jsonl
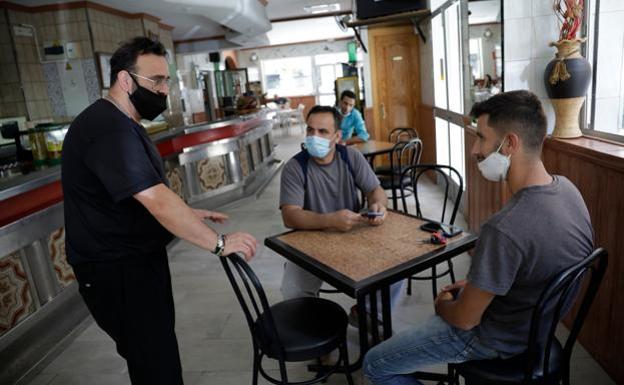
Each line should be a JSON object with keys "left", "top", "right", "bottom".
{"left": 470, "top": 91, "right": 548, "bottom": 153}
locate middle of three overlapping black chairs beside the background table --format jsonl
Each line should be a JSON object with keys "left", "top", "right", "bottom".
{"left": 377, "top": 138, "right": 423, "bottom": 210}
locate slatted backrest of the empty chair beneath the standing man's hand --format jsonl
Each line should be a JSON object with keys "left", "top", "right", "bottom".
{"left": 220, "top": 254, "right": 284, "bottom": 355}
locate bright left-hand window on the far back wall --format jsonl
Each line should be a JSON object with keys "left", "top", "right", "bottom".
{"left": 261, "top": 56, "right": 314, "bottom": 96}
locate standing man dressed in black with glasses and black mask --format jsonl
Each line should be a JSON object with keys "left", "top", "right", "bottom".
{"left": 62, "top": 37, "right": 256, "bottom": 385}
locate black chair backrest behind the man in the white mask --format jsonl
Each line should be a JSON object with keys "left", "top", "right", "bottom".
{"left": 524, "top": 248, "right": 607, "bottom": 382}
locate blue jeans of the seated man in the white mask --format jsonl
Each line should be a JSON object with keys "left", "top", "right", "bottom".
{"left": 362, "top": 316, "right": 499, "bottom": 385}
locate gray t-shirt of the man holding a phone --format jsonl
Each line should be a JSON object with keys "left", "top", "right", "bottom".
{"left": 280, "top": 147, "right": 379, "bottom": 214}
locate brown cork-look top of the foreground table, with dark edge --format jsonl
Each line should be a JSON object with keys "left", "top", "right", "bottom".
{"left": 265, "top": 212, "right": 476, "bottom": 294}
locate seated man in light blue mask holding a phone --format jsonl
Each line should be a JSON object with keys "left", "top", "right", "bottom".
{"left": 280, "top": 106, "right": 400, "bottom": 322}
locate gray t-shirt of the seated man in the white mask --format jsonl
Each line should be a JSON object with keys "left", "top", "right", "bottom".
{"left": 468, "top": 175, "right": 593, "bottom": 357}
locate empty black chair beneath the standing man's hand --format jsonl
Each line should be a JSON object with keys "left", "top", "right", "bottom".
{"left": 221, "top": 254, "right": 353, "bottom": 385}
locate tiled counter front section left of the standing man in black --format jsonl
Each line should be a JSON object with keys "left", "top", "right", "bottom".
{"left": 0, "top": 203, "right": 88, "bottom": 384}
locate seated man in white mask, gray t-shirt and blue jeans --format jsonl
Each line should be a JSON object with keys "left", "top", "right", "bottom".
{"left": 362, "top": 91, "right": 593, "bottom": 385}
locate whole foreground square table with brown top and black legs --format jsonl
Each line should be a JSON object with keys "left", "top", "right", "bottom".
{"left": 264, "top": 211, "right": 477, "bottom": 370}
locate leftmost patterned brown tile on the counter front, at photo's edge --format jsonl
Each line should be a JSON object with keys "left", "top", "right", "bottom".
{"left": 0, "top": 252, "right": 35, "bottom": 335}
